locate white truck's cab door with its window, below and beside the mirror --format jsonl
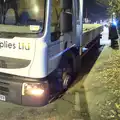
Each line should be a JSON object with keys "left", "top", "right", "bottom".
{"left": 48, "top": 0, "right": 74, "bottom": 73}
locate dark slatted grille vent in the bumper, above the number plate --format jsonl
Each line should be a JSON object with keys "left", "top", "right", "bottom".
{"left": 0, "top": 81, "right": 9, "bottom": 95}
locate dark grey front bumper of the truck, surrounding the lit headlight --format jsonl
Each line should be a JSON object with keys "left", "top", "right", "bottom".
{"left": 0, "top": 73, "right": 49, "bottom": 107}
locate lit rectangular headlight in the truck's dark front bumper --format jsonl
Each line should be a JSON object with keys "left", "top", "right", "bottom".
{"left": 22, "top": 83, "right": 45, "bottom": 96}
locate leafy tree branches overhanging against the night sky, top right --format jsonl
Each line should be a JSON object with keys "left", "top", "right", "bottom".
{"left": 97, "top": 0, "right": 120, "bottom": 18}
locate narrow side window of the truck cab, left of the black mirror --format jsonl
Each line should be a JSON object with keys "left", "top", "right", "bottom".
{"left": 51, "top": 0, "right": 61, "bottom": 41}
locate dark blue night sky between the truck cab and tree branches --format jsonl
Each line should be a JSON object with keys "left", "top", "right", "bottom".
{"left": 83, "top": 0, "right": 107, "bottom": 21}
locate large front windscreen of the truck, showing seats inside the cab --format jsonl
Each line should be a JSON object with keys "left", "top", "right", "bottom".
{"left": 0, "top": 0, "right": 45, "bottom": 33}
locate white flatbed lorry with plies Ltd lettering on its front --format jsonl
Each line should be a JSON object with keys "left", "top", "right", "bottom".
{"left": 0, "top": 0, "right": 102, "bottom": 106}
